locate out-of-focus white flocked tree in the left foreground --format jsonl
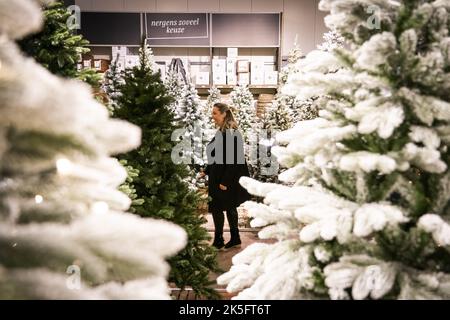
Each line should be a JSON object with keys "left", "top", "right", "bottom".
{"left": 0, "top": 0, "right": 186, "bottom": 299}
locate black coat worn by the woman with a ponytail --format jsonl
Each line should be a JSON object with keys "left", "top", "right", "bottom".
{"left": 206, "top": 130, "right": 251, "bottom": 212}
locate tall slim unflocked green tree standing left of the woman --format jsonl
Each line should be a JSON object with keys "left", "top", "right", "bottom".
{"left": 114, "top": 43, "right": 217, "bottom": 297}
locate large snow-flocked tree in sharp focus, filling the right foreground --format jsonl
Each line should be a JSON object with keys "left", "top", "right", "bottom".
{"left": 218, "top": 0, "right": 450, "bottom": 299}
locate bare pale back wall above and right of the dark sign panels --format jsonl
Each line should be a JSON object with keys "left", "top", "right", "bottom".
{"left": 73, "top": 0, "right": 328, "bottom": 56}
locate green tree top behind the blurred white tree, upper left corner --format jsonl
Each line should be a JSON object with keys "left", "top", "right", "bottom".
{"left": 18, "top": 1, "right": 101, "bottom": 88}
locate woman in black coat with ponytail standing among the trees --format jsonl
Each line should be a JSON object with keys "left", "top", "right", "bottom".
{"left": 205, "top": 103, "right": 250, "bottom": 250}
